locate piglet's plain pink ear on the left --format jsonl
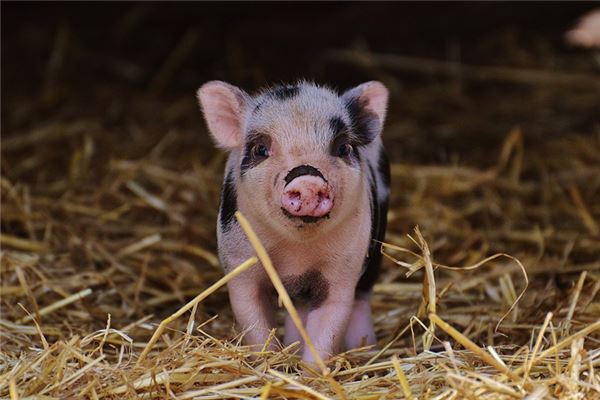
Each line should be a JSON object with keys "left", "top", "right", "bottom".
{"left": 198, "top": 81, "right": 250, "bottom": 150}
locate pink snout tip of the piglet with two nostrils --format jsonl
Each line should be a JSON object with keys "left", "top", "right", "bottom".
{"left": 281, "top": 175, "right": 333, "bottom": 217}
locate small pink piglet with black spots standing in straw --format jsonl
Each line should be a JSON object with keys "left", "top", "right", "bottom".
{"left": 198, "top": 81, "right": 390, "bottom": 363}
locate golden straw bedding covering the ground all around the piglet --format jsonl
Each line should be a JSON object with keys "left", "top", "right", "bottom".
{"left": 0, "top": 5, "right": 600, "bottom": 399}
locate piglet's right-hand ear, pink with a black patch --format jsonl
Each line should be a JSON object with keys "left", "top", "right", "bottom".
{"left": 342, "top": 81, "right": 389, "bottom": 144}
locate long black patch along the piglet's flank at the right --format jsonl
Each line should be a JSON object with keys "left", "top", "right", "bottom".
{"left": 356, "top": 166, "right": 388, "bottom": 297}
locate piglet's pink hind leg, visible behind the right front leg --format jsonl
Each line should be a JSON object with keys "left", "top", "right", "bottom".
{"left": 344, "top": 293, "right": 377, "bottom": 350}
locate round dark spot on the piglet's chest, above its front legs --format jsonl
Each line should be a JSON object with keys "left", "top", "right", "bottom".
{"left": 282, "top": 269, "right": 329, "bottom": 310}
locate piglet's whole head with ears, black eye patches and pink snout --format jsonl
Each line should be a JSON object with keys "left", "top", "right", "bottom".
{"left": 198, "top": 81, "right": 388, "bottom": 238}
